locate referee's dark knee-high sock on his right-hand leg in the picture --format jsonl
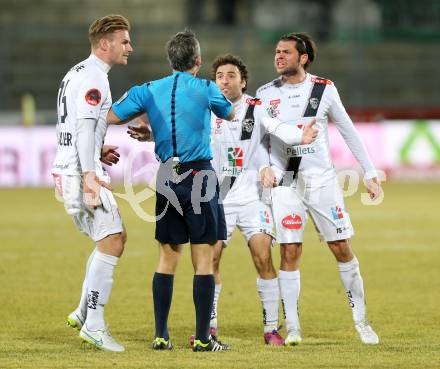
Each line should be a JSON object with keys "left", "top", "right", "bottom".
{"left": 193, "top": 274, "right": 215, "bottom": 343}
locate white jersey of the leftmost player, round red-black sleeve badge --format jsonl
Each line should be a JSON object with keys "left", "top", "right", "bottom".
{"left": 52, "top": 54, "right": 112, "bottom": 176}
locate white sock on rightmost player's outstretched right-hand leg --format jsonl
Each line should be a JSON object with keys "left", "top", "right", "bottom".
{"left": 338, "top": 256, "right": 365, "bottom": 323}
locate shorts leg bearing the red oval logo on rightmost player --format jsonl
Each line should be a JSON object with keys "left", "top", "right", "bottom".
{"left": 272, "top": 186, "right": 307, "bottom": 243}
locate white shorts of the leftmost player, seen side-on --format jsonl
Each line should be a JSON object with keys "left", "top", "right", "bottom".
{"left": 53, "top": 174, "right": 124, "bottom": 242}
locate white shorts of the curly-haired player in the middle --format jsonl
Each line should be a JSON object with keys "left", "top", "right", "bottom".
{"left": 223, "top": 200, "right": 275, "bottom": 246}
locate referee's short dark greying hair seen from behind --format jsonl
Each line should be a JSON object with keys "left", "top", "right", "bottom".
{"left": 166, "top": 29, "right": 200, "bottom": 72}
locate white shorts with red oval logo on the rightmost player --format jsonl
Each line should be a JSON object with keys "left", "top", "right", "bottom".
{"left": 272, "top": 178, "right": 354, "bottom": 243}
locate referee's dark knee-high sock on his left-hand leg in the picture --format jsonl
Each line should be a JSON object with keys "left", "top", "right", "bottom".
{"left": 153, "top": 272, "right": 174, "bottom": 340}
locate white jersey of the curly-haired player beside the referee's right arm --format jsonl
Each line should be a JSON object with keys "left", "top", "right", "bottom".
{"left": 211, "top": 94, "right": 269, "bottom": 205}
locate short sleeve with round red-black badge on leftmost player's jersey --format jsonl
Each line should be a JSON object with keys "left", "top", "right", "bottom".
{"left": 75, "top": 77, "right": 109, "bottom": 119}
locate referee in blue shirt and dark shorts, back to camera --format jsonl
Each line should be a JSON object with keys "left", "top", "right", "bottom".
{"left": 107, "top": 30, "right": 234, "bottom": 351}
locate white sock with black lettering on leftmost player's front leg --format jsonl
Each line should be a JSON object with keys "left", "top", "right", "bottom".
{"left": 86, "top": 250, "right": 119, "bottom": 331}
